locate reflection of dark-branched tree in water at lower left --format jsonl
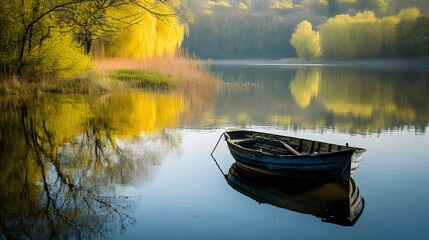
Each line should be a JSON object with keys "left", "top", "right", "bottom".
{"left": 0, "top": 93, "right": 180, "bottom": 239}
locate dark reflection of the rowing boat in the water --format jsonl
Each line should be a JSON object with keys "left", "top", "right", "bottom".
{"left": 226, "top": 163, "right": 365, "bottom": 226}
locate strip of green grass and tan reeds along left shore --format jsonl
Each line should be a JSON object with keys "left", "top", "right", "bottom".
{"left": 0, "top": 56, "right": 219, "bottom": 96}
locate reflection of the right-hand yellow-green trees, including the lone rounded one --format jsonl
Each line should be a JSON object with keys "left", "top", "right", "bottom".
{"left": 289, "top": 67, "right": 429, "bottom": 133}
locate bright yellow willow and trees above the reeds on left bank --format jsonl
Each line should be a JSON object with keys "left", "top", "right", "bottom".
{"left": 0, "top": 0, "right": 188, "bottom": 78}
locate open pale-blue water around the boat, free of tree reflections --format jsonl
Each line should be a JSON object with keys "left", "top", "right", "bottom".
{"left": 113, "top": 126, "right": 429, "bottom": 239}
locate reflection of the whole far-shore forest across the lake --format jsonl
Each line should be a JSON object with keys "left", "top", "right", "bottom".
{"left": 188, "top": 64, "right": 429, "bottom": 134}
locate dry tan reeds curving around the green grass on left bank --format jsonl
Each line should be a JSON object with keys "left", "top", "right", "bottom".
{"left": 0, "top": 56, "right": 221, "bottom": 117}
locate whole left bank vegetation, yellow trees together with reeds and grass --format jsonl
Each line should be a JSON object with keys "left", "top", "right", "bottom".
{"left": 0, "top": 0, "right": 216, "bottom": 95}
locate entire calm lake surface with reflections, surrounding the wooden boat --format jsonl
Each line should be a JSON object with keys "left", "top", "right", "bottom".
{"left": 0, "top": 63, "right": 429, "bottom": 239}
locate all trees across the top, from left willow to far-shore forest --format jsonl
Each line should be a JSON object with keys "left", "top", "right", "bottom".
{"left": 0, "top": 0, "right": 429, "bottom": 82}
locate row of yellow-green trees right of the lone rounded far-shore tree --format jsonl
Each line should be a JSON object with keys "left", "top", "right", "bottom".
{"left": 319, "top": 8, "right": 424, "bottom": 59}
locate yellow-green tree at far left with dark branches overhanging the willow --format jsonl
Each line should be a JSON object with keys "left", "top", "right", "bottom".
{"left": 0, "top": 0, "right": 185, "bottom": 76}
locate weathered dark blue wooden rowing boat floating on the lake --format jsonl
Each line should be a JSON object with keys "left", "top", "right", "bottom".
{"left": 224, "top": 129, "right": 366, "bottom": 183}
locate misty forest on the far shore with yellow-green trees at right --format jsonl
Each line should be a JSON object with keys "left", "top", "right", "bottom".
{"left": 183, "top": 0, "right": 429, "bottom": 60}
